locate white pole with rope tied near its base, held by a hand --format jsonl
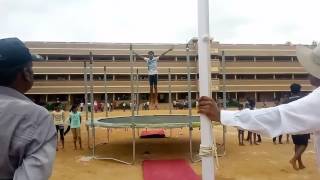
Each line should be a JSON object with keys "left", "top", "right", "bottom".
{"left": 198, "top": 0, "right": 215, "bottom": 180}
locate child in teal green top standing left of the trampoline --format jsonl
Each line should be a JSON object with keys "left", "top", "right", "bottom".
{"left": 69, "top": 106, "right": 82, "bottom": 150}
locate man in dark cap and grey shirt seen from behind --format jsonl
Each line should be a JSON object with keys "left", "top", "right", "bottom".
{"left": 0, "top": 38, "right": 56, "bottom": 180}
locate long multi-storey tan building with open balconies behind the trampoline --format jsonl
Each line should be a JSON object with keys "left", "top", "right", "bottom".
{"left": 26, "top": 39, "right": 312, "bottom": 107}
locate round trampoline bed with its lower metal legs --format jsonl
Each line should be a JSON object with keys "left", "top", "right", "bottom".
{"left": 87, "top": 115, "right": 219, "bottom": 164}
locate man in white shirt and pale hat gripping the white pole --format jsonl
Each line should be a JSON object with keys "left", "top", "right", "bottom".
{"left": 199, "top": 46, "right": 320, "bottom": 169}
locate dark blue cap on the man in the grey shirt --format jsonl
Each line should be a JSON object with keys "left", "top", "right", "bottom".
{"left": 0, "top": 38, "right": 43, "bottom": 69}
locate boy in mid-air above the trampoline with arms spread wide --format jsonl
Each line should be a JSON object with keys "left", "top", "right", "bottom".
{"left": 134, "top": 48, "right": 173, "bottom": 109}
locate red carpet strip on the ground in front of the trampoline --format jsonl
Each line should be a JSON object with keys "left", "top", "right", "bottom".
{"left": 143, "top": 160, "right": 200, "bottom": 180}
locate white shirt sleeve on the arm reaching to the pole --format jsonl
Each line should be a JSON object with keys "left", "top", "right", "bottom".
{"left": 221, "top": 89, "right": 320, "bottom": 137}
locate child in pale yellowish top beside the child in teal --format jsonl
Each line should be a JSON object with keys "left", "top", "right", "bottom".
{"left": 52, "top": 104, "right": 65, "bottom": 151}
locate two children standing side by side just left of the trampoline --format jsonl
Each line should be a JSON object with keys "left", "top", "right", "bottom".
{"left": 51, "top": 104, "right": 82, "bottom": 151}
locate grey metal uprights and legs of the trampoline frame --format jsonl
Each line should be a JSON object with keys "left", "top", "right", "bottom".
{"left": 84, "top": 44, "right": 225, "bottom": 165}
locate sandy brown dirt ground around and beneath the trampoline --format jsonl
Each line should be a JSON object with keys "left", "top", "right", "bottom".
{"left": 51, "top": 110, "right": 320, "bottom": 180}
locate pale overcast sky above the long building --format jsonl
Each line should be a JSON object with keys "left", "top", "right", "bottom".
{"left": 0, "top": 0, "right": 320, "bottom": 44}
